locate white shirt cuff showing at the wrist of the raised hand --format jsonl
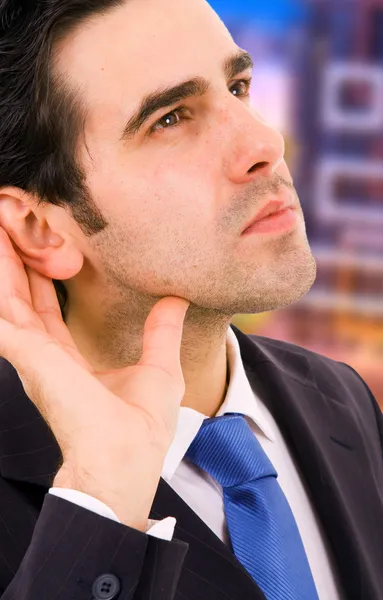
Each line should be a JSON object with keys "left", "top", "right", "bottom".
{"left": 49, "top": 487, "right": 176, "bottom": 542}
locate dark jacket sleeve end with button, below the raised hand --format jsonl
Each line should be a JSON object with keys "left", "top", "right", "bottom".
{"left": 1, "top": 493, "right": 189, "bottom": 600}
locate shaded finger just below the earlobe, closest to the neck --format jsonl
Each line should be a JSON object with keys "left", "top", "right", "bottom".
{"left": 25, "top": 267, "right": 90, "bottom": 370}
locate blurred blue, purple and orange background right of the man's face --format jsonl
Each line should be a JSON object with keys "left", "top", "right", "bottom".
{"left": 210, "top": 0, "right": 383, "bottom": 409}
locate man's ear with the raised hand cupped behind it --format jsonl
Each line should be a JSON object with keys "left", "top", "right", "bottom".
{"left": 0, "top": 187, "right": 84, "bottom": 280}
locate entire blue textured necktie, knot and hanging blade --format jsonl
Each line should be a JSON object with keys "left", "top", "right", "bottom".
{"left": 186, "top": 413, "right": 318, "bottom": 600}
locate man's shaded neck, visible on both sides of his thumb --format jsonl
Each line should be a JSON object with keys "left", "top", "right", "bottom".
{"left": 66, "top": 299, "right": 231, "bottom": 417}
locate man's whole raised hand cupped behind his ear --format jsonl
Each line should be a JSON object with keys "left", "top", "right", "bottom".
{"left": 0, "top": 227, "right": 190, "bottom": 531}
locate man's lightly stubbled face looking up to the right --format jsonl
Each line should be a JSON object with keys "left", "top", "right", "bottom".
{"left": 58, "top": 0, "right": 315, "bottom": 314}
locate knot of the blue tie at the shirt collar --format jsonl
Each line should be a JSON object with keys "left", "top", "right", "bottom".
{"left": 186, "top": 413, "right": 277, "bottom": 487}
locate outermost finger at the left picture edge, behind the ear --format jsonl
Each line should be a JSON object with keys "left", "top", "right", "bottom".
{"left": 0, "top": 227, "right": 44, "bottom": 330}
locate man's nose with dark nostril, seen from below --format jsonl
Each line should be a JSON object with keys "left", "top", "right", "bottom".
{"left": 226, "top": 99, "right": 285, "bottom": 183}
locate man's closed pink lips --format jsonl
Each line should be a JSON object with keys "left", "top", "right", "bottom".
{"left": 241, "top": 190, "right": 298, "bottom": 236}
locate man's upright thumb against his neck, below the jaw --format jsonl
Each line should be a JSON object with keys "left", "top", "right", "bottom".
{"left": 138, "top": 296, "right": 190, "bottom": 377}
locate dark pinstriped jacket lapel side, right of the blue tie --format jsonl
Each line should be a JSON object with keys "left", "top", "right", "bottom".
{"left": 234, "top": 328, "right": 383, "bottom": 600}
